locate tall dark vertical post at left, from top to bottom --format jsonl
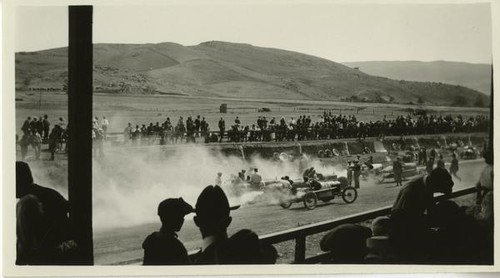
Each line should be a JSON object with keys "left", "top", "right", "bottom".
{"left": 68, "top": 6, "right": 94, "bottom": 265}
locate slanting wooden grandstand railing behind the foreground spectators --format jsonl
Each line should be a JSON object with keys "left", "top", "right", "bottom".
{"left": 113, "top": 187, "right": 477, "bottom": 264}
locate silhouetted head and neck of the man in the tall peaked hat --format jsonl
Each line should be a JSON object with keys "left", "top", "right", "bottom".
{"left": 194, "top": 185, "right": 232, "bottom": 238}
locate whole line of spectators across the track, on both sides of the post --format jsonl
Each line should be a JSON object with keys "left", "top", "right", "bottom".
{"left": 16, "top": 111, "right": 490, "bottom": 160}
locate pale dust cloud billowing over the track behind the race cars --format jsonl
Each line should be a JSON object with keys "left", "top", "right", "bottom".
{"left": 93, "top": 145, "right": 345, "bottom": 230}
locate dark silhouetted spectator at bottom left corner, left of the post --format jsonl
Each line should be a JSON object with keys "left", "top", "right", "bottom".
{"left": 16, "top": 161, "right": 77, "bottom": 265}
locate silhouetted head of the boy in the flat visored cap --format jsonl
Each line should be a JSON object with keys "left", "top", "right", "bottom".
{"left": 158, "top": 198, "right": 194, "bottom": 232}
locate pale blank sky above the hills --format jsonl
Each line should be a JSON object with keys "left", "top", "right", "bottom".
{"left": 15, "top": 2, "right": 491, "bottom": 63}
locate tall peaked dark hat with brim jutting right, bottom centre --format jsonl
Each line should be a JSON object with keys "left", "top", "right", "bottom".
{"left": 195, "top": 185, "right": 239, "bottom": 223}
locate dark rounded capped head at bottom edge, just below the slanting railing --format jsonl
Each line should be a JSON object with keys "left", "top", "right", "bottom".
{"left": 320, "top": 224, "right": 372, "bottom": 264}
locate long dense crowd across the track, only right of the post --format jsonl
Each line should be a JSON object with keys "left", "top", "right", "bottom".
{"left": 120, "top": 112, "right": 489, "bottom": 144}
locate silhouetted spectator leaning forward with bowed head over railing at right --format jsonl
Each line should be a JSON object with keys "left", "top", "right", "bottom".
{"left": 391, "top": 167, "right": 453, "bottom": 263}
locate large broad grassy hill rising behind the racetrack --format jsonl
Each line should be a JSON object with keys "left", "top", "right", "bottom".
{"left": 16, "top": 41, "right": 488, "bottom": 106}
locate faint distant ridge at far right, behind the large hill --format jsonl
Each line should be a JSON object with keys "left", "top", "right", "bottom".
{"left": 344, "top": 61, "right": 491, "bottom": 95}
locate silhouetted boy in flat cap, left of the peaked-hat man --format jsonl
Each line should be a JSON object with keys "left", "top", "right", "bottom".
{"left": 142, "top": 198, "right": 193, "bottom": 265}
